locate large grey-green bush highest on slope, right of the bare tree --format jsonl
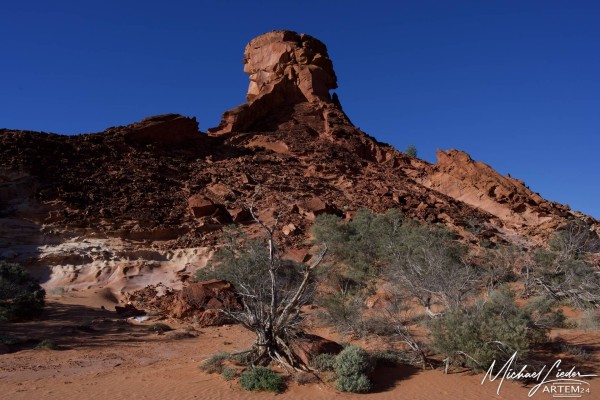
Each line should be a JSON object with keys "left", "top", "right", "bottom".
{"left": 313, "top": 210, "right": 481, "bottom": 311}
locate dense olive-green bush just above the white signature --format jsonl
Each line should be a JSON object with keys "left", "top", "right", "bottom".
{"left": 429, "top": 290, "right": 547, "bottom": 370}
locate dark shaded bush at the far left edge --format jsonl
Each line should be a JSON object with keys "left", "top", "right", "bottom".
{"left": 0, "top": 261, "right": 46, "bottom": 321}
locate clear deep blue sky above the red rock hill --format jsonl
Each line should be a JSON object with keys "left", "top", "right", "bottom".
{"left": 0, "top": 0, "right": 600, "bottom": 218}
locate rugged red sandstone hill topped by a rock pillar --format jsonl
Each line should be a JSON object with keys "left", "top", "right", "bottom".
{"left": 0, "top": 31, "right": 600, "bottom": 297}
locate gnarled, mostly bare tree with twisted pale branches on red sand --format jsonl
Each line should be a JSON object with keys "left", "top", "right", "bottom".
{"left": 199, "top": 192, "right": 327, "bottom": 370}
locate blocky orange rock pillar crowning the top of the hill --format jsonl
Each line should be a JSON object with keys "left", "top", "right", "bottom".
{"left": 209, "top": 31, "right": 339, "bottom": 134}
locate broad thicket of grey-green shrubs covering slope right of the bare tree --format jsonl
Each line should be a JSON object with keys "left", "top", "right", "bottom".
{"left": 313, "top": 210, "right": 599, "bottom": 371}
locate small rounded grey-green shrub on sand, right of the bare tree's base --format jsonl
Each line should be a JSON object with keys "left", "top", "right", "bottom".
{"left": 334, "top": 346, "right": 374, "bottom": 393}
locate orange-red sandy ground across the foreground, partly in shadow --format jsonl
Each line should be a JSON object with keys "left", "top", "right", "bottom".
{"left": 0, "top": 294, "right": 600, "bottom": 400}
